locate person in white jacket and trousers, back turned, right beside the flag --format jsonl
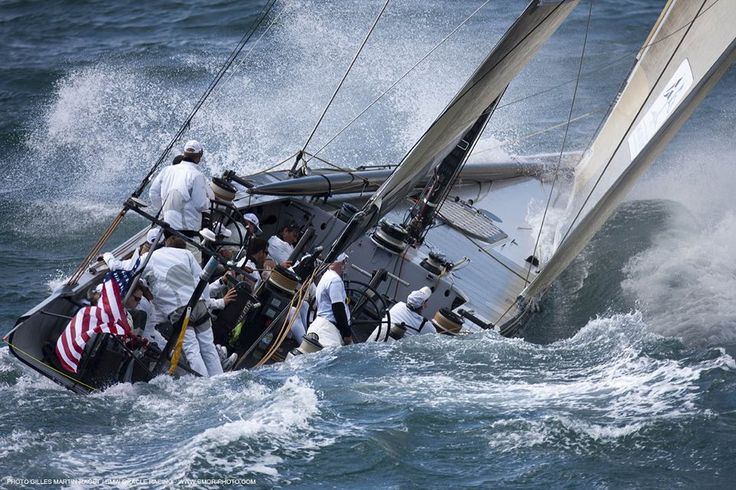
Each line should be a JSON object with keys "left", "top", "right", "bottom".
{"left": 141, "top": 236, "right": 235, "bottom": 376}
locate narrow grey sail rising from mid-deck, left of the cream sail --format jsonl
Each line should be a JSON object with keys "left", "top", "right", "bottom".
{"left": 326, "top": 0, "right": 578, "bottom": 260}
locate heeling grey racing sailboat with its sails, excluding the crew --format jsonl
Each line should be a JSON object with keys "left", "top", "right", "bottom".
{"left": 5, "top": 0, "right": 736, "bottom": 393}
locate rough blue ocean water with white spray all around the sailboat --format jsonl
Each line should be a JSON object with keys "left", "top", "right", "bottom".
{"left": 0, "top": 0, "right": 736, "bottom": 489}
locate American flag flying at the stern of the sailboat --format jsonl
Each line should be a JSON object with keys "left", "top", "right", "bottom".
{"left": 56, "top": 259, "right": 140, "bottom": 373}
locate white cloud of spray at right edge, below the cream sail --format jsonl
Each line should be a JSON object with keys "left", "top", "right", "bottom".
{"left": 622, "top": 154, "right": 736, "bottom": 346}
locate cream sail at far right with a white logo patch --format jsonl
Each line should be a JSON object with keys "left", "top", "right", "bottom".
{"left": 516, "top": 0, "right": 736, "bottom": 310}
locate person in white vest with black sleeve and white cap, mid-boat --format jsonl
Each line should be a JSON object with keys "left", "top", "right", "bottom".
{"left": 307, "top": 253, "right": 353, "bottom": 347}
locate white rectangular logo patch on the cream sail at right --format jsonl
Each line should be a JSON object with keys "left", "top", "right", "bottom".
{"left": 628, "top": 58, "right": 693, "bottom": 160}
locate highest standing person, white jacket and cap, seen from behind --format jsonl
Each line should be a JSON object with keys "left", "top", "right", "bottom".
{"left": 149, "top": 140, "right": 214, "bottom": 261}
